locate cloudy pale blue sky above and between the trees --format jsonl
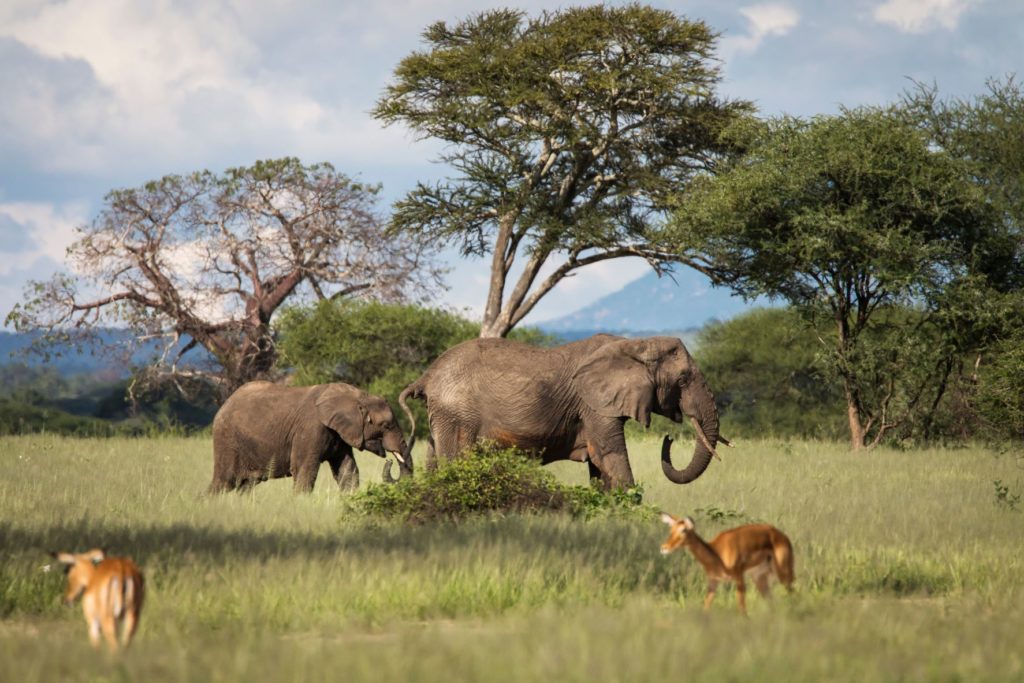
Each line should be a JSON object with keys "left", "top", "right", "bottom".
{"left": 0, "top": 0, "right": 1024, "bottom": 322}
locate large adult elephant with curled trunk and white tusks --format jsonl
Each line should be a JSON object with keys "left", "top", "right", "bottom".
{"left": 398, "top": 335, "right": 719, "bottom": 488}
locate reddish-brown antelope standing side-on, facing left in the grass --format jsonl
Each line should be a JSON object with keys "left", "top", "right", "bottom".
{"left": 662, "top": 512, "right": 793, "bottom": 614}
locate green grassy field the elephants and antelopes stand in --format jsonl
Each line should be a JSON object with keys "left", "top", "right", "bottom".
{"left": 0, "top": 436, "right": 1024, "bottom": 683}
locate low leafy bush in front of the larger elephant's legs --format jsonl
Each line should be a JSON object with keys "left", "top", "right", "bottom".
{"left": 349, "top": 443, "right": 655, "bottom": 522}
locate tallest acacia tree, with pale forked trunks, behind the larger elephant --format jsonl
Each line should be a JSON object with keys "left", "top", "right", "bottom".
{"left": 374, "top": 4, "right": 752, "bottom": 337}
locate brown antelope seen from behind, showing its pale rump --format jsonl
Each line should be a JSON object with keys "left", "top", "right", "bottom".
{"left": 53, "top": 550, "right": 144, "bottom": 650}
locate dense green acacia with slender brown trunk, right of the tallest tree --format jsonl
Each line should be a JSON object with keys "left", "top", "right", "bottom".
{"left": 674, "top": 109, "right": 1017, "bottom": 450}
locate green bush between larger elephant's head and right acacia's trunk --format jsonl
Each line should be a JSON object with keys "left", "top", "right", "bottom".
{"left": 694, "top": 308, "right": 845, "bottom": 438}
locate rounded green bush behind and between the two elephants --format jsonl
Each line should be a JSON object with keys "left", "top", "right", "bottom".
{"left": 276, "top": 300, "right": 552, "bottom": 436}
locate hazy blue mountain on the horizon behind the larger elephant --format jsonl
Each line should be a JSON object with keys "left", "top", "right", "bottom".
{"left": 536, "top": 267, "right": 770, "bottom": 342}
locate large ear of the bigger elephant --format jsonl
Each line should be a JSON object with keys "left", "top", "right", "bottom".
{"left": 572, "top": 339, "right": 654, "bottom": 427}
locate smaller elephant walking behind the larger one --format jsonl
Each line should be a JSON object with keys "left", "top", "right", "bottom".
{"left": 210, "top": 382, "right": 412, "bottom": 494}
